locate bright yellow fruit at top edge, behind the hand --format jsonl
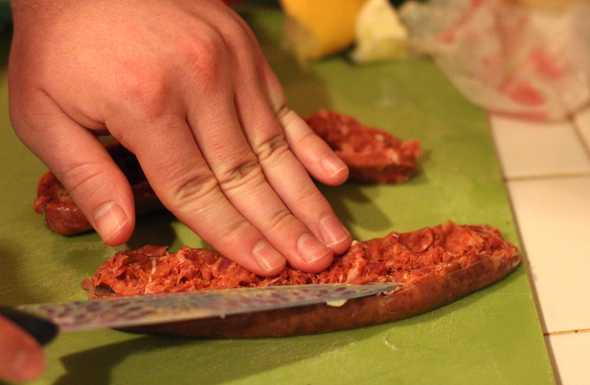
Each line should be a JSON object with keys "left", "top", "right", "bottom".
{"left": 281, "top": 0, "right": 366, "bottom": 60}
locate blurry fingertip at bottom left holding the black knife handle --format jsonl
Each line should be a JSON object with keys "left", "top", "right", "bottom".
{"left": 0, "top": 317, "right": 45, "bottom": 382}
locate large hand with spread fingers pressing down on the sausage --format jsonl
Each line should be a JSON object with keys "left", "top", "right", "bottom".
{"left": 9, "top": 0, "right": 351, "bottom": 275}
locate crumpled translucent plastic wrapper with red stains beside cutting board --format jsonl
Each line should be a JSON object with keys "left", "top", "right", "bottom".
{"left": 401, "top": 0, "right": 590, "bottom": 120}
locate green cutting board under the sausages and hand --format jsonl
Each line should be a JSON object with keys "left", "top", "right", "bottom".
{"left": 0, "top": 8, "right": 554, "bottom": 385}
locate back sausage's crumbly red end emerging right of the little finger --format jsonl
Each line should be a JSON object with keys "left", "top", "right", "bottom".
{"left": 306, "top": 110, "right": 422, "bottom": 183}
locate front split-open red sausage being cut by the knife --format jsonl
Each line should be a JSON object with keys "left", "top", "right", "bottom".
{"left": 83, "top": 223, "right": 521, "bottom": 337}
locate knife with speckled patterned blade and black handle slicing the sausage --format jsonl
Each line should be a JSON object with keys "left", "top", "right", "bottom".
{"left": 0, "top": 283, "right": 397, "bottom": 345}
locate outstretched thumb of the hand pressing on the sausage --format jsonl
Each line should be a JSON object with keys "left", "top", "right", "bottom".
{"left": 13, "top": 93, "right": 135, "bottom": 245}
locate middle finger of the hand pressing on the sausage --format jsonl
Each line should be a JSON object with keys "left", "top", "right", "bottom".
{"left": 182, "top": 25, "right": 332, "bottom": 271}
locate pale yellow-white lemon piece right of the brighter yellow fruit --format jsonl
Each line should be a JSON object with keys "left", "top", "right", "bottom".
{"left": 351, "top": 0, "right": 408, "bottom": 63}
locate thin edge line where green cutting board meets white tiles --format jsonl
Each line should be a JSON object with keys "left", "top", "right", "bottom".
{"left": 488, "top": 112, "right": 563, "bottom": 385}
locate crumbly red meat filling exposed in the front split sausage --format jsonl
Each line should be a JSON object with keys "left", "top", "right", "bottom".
{"left": 86, "top": 223, "right": 518, "bottom": 296}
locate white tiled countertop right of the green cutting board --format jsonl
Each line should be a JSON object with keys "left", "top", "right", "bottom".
{"left": 491, "top": 109, "right": 590, "bottom": 385}
